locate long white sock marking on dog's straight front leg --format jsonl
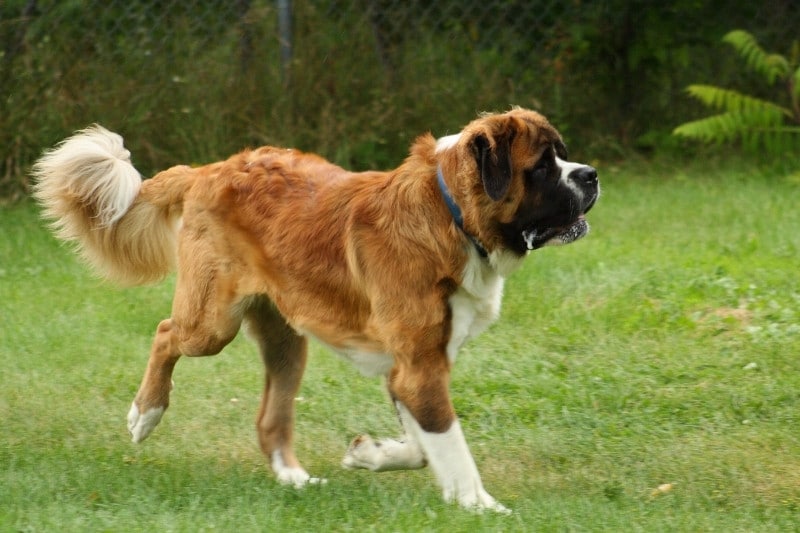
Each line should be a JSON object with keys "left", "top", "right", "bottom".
{"left": 397, "top": 402, "right": 511, "bottom": 513}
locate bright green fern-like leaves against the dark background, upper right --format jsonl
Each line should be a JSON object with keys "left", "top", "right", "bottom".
{"left": 674, "top": 30, "right": 800, "bottom": 153}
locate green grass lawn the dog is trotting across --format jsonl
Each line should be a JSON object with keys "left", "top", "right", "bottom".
{"left": 0, "top": 160, "right": 800, "bottom": 532}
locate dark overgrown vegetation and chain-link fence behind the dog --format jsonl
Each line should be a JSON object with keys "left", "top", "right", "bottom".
{"left": 0, "top": 0, "right": 800, "bottom": 200}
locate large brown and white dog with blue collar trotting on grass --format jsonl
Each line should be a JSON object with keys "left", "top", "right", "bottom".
{"left": 32, "top": 108, "right": 600, "bottom": 512}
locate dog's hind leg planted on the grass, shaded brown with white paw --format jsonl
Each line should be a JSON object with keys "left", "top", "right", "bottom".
{"left": 245, "top": 298, "right": 325, "bottom": 487}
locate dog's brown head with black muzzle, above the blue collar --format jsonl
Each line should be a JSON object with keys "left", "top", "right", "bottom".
{"left": 437, "top": 108, "right": 600, "bottom": 264}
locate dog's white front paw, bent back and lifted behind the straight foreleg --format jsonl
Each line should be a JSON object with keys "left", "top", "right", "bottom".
{"left": 342, "top": 435, "right": 426, "bottom": 472}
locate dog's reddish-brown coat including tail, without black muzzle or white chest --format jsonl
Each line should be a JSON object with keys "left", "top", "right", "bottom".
{"left": 35, "top": 109, "right": 592, "bottom": 498}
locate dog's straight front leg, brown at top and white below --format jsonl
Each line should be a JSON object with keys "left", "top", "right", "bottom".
{"left": 390, "top": 362, "right": 510, "bottom": 513}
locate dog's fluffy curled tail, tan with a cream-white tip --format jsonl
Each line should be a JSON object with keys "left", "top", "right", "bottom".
{"left": 33, "top": 125, "right": 187, "bottom": 285}
